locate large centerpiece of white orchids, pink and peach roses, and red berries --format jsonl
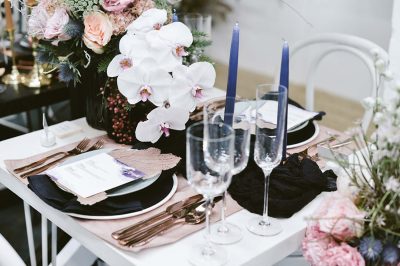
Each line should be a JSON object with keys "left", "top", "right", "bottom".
{"left": 28, "top": 0, "right": 216, "bottom": 143}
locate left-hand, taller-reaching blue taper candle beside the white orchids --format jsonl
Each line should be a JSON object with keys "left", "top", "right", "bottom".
{"left": 224, "top": 23, "right": 240, "bottom": 125}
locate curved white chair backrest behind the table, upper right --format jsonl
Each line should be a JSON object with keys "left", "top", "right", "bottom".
{"left": 278, "top": 33, "right": 389, "bottom": 132}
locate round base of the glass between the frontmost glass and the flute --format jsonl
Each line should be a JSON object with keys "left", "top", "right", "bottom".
{"left": 210, "top": 223, "right": 243, "bottom": 245}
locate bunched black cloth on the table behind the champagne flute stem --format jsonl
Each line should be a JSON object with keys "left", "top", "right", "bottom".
{"left": 228, "top": 143, "right": 336, "bottom": 218}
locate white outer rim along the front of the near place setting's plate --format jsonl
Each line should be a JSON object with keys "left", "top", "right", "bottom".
{"left": 67, "top": 174, "right": 178, "bottom": 220}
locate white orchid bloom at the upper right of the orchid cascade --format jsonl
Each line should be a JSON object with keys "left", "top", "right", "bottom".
{"left": 146, "top": 22, "right": 193, "bottom": 71}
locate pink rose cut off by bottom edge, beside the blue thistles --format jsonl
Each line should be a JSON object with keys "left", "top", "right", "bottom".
{"left": 322, "top": 243, "right": 365, "bottom": 266}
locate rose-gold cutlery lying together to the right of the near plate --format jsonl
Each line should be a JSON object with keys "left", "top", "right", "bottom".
{"left": 111, "top": 194, "right": 216, "bottom": 247}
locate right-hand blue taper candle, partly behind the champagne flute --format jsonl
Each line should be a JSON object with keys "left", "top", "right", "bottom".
{"left": 279, "top": 41, "right": 289, "bottom": 160}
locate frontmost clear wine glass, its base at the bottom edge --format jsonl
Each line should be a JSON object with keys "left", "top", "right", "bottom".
{"left": 186, "top": 122, "right": 234, "bottom": 265}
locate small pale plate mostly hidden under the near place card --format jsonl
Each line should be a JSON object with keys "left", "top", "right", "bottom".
{"left": 60, "top": 149, "right": 161, "bottom": 197}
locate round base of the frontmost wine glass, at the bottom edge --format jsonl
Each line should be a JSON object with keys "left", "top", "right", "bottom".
{"left": 188, "top": 244, "right": 228, "bottom": 266}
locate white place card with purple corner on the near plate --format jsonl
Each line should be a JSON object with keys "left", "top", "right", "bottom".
{"left": 46, "top": 153, "right": 145, "bottom": 198}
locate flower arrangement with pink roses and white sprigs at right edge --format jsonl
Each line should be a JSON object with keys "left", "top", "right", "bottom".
{"left": 302, "top": 78, "right": 400, "bottom": 266}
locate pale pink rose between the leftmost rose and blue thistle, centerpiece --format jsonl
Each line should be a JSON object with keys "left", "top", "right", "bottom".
{"left": 44, "top": 8, "right": 69, "bottom": 40}
